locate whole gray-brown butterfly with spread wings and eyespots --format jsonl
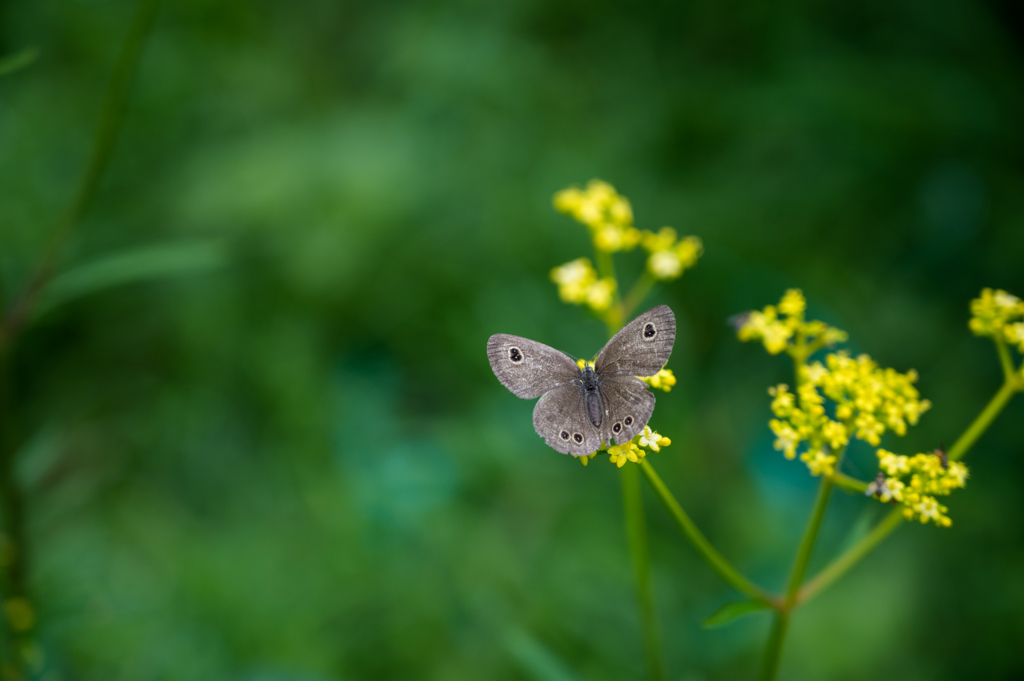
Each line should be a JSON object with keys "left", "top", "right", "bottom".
{"left": 487, "top": 305, "right": 676, "bottom": 457}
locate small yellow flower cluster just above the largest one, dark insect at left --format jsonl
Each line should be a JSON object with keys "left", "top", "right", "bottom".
{"left": 736, "top": 289, "right": 847, "bottom": 356}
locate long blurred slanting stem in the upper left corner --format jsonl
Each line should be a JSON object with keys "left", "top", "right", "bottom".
{"left": 0, "top": 0, "right": 160, "bottom": 342}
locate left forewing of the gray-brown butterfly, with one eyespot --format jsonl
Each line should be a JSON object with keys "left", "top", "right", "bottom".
{"left": 487, "top": 334, "right": 580, "bottom": 399}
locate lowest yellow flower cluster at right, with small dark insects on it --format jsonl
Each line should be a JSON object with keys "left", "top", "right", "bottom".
{"left": 865, "top": 450, "right": 968, "bottom": 527}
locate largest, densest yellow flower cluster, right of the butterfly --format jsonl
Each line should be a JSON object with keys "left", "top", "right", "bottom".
{"left": 768, "top": 352, "right": 931, "bottom": 475}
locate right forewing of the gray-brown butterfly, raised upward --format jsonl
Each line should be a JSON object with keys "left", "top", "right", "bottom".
{"left": 598, "top": 305, "right": 676, "bottom": 378}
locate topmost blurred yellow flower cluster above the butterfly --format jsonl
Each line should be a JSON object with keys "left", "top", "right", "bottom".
{"left": 555, "top": 179, "right": 641, "bottom": 253}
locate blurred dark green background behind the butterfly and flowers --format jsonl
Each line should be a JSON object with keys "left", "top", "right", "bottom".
{"left": 0, "top": 0, "right": 1024, "bottom": 681}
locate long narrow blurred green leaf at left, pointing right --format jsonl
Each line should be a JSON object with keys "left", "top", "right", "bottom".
{"left": 38, "top": 242, "right": 226, "bottom": 315}
